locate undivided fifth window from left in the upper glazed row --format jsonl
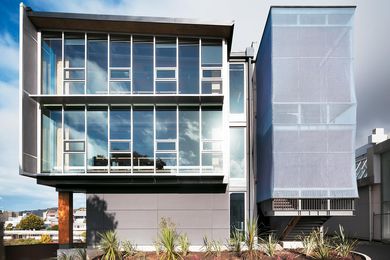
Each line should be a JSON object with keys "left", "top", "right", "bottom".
{"left": 133, "top": 36, "right": 153, "bottom": 94}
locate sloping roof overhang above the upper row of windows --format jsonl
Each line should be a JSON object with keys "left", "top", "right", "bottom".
{"left": 27, "top": 9, "right": 234, "bottom": 53}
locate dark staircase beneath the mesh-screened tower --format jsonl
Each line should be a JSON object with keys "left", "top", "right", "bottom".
{"left": 280, "top": 216, "right": 329, "bottom": 241}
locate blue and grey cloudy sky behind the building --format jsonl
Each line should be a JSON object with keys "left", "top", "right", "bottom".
{"left": 0, "top": 0, "right": 390, "bottom": 210}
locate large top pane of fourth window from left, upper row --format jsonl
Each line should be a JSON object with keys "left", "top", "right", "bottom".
{"left": 110, "top": 35, "right": 131, "bottom": 68}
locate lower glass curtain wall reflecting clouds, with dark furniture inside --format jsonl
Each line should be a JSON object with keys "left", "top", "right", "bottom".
{"left": 41, "top": 105, "right": 222, "bottom": 174}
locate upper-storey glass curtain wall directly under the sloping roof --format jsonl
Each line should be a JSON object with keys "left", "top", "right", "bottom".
{"left": 41, "top": 32, "right": 223, "bottom": 95}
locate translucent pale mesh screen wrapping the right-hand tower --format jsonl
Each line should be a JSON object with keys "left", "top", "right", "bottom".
{"left": 256, "top": 7, "right": 357, "bottom": 200}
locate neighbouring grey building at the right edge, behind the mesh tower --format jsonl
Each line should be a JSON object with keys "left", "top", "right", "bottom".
{"left": 325, "top": 128, "right": 390, "bottom": 242}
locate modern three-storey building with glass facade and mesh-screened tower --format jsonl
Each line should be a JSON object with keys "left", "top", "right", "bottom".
{"left": 20, "top": 5, "right": 357, "bottom": 249}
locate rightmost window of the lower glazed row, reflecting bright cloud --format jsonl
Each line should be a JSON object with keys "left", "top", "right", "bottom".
{"left": 201, "top": 106, "right": 223, "bottom": 172}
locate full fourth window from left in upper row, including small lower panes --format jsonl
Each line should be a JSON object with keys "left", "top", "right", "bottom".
{"left": 110, "top": 35, "right": 131, "bottom": 93}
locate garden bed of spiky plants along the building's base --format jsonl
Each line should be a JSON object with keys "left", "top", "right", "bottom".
{"left": 59, "top": 218, "right": 364, "bottom": 260}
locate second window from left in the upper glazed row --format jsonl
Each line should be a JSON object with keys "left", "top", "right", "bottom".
{"left": 64, "top": 33, "right": 85, "bottom": 94}
